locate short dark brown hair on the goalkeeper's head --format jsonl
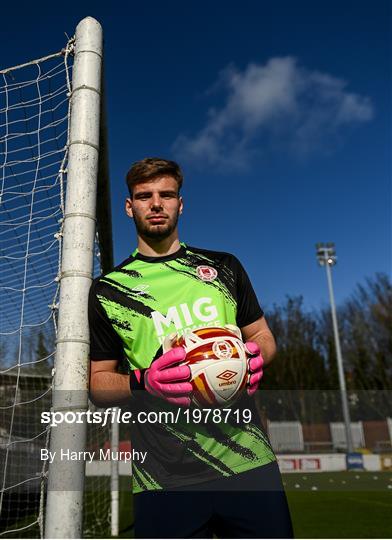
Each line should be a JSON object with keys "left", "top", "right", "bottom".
{"left": 126, "top": 157, "right": 184, "bottom": 197}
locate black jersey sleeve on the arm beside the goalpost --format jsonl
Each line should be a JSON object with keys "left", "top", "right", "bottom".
{"left": 88, "top": 281, "right": 124, "bottom": 360}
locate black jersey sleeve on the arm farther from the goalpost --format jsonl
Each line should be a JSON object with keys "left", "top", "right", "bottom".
{"left": 234, "top": 257, "right": 264, "bottom": 328}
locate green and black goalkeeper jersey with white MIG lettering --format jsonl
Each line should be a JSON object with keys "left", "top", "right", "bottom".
{"left": 89, "top": 244, "right": 275, "bottom": 493}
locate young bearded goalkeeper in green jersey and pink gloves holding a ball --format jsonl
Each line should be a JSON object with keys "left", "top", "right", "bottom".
{"left": 89, "top": 158, "right": 292, "bottom": 538}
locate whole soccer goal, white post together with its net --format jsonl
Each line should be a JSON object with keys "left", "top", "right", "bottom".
{"left": 0, "top": 17, "right": 118, "bottom": 538}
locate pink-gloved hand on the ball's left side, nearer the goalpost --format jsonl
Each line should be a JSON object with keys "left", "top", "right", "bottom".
{"left": 144, "top": 347, "right": 192, "bottom": 407}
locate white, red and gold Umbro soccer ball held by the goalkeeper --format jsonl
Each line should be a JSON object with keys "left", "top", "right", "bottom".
{"left": 164, "top": 325, "right": 248, "bottom": 407}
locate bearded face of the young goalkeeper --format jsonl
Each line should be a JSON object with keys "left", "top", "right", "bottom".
{"left": 125, "top": 176, "right": 183, "bottom": 240}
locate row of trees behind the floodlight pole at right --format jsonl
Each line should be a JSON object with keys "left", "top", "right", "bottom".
{"left": 259, "top": 273, "right": 392, "bottom": 422}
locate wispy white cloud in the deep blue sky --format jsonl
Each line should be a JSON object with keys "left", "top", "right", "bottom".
{"left": 173, "top": 57, "right": 373, "bottom": 168}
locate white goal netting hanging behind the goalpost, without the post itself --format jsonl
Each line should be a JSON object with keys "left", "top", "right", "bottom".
{"left": 0, "top": 17, "right": 112, "bottom": 538}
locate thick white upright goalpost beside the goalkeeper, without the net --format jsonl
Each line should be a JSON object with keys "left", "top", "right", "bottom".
{"left": 45, "top": 14, "right": 102, "bottom": 538}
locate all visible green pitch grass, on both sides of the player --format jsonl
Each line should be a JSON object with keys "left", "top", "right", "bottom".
{"left": 1, "top": 471, "right": 392, "bottom": 538}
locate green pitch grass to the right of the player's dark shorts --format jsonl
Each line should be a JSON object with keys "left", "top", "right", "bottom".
{"left": 283, "top": 471, "right": 392, "bottom": 538}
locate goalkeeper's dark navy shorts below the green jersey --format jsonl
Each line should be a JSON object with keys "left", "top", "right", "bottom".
{"left": 134, "top": 462, "right": 293, "bottom": 538}
